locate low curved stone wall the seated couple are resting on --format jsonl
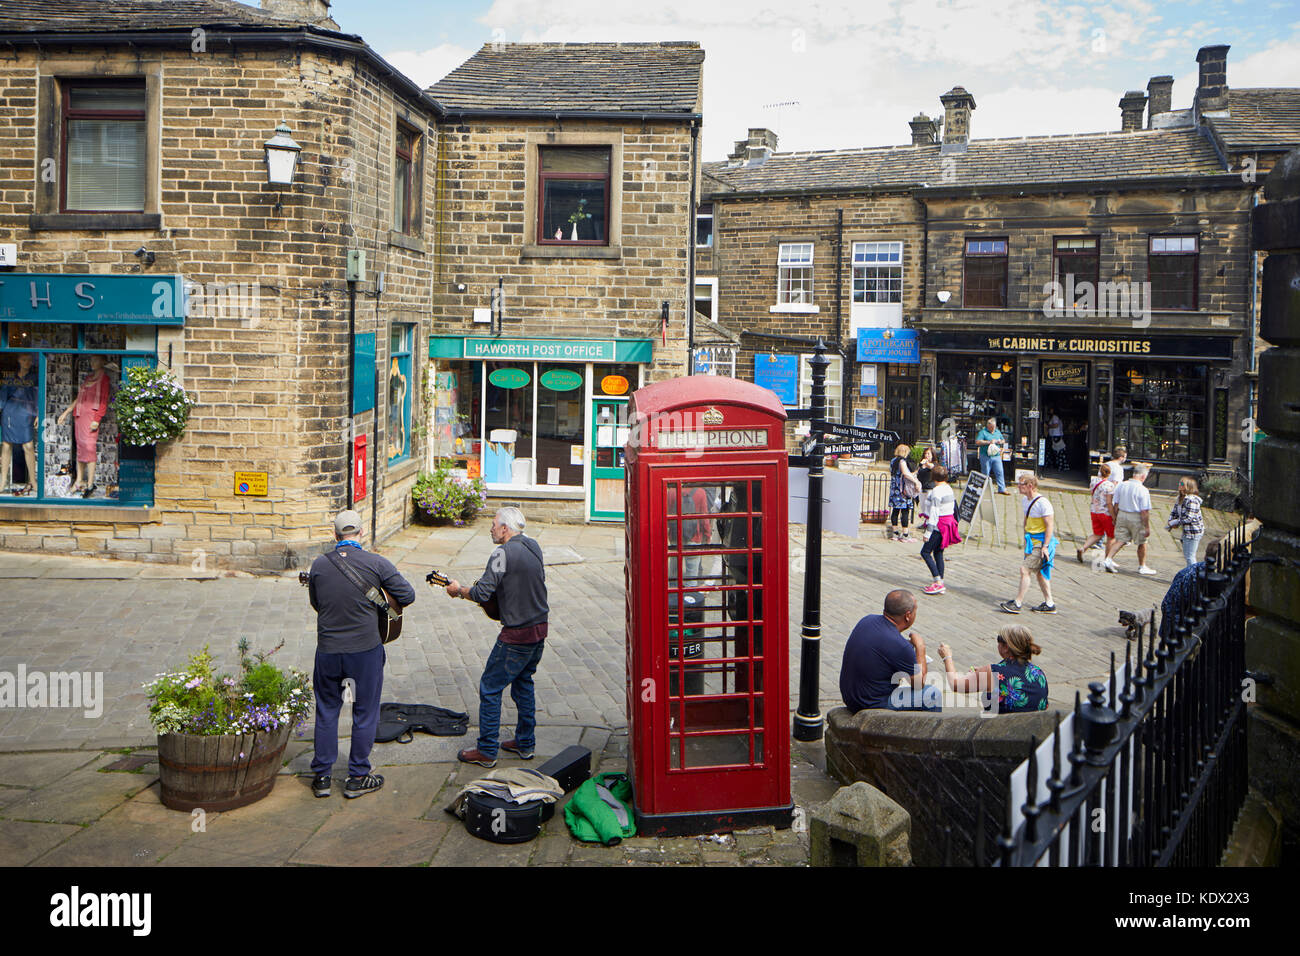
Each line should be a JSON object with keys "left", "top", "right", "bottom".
{"left": 826, "top": 708, "right": 1057, "bottom": 866}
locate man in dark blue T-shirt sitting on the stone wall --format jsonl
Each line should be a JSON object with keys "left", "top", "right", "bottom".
{"left": 840, "top": 591, "right": 943, "bottom": 713}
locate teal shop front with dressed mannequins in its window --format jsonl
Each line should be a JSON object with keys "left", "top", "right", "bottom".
{"left": 0, "top": 273, "right": 186, "bottom": 507}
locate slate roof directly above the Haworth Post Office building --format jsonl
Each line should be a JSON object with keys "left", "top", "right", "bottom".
{"left": 426, "top": 43, "right": 705, "bottom": 116}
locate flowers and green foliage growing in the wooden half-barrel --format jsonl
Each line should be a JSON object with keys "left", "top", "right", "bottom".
{"left": 144, "top": 637, "right": 312, "bottom": 736}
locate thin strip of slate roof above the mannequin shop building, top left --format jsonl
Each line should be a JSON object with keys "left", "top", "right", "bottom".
{"left": 0, "top": 0, "right": 345, "bottom": 34}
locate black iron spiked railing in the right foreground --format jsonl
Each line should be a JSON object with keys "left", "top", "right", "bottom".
{"left": 975, "top": 524, "right": 1251, "bottom": 866}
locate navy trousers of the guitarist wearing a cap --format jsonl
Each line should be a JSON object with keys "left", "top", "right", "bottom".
{"left": 312, "top": 644, "right": 387, "bottom": 777}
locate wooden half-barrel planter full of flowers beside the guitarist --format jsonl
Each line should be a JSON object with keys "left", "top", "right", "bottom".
{"left": 144, "top": 637, "right": 312, "bottom": 810}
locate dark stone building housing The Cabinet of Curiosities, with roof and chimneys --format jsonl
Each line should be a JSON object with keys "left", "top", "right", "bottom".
{"left": 701, "top": 47, "right": 1300, "bottom": 481}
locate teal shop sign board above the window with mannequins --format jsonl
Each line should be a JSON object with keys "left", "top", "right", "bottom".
{"left": 0, "top": 272, "right": 186, "bottom": 325}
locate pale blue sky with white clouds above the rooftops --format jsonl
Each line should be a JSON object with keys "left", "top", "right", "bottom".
{"left": 332, "top": 0, "right": 1300, "bottom": 160}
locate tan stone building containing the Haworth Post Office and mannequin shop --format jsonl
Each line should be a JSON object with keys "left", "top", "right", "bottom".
{"left": 0, "top": 0, "right": 703, "bottom": 570}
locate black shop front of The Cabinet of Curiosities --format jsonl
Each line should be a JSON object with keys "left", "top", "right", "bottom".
{"left": 922, "top": 330, "right": 1232, "bottom": 481}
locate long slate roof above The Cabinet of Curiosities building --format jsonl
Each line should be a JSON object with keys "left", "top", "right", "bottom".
{"left": 702, "top": 129, "right": 1229, "bottom": 198}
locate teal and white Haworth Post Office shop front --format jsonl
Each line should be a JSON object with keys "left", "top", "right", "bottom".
{"left": 425, "top": 336, "right": 654, "bottom": 522}
